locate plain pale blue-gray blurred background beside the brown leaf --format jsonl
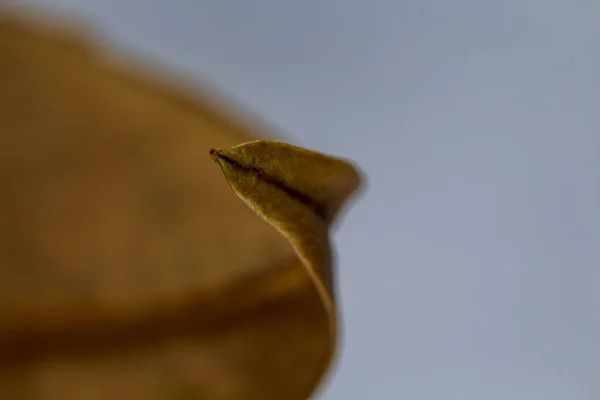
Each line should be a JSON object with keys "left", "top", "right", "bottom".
{"left": 18, "top": 0, "right": 600, "bottom": 400}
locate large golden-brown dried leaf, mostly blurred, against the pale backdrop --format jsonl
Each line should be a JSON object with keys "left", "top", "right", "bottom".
{"left": 0, "top": 9, "right": 358, "bottom": 400}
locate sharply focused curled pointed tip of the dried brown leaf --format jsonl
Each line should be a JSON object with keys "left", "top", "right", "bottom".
{"left": 210, "top": 140, "right": 360, "bottom": 394}
